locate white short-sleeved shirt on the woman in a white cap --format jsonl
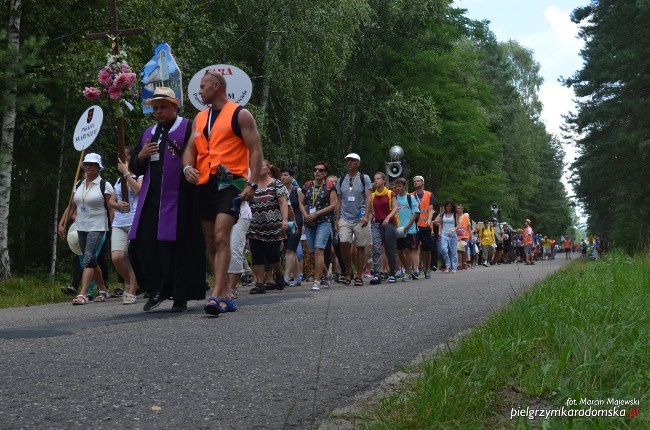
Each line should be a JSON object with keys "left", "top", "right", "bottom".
{"left": 74, "top": 176, "right": 113, "bottom": 231}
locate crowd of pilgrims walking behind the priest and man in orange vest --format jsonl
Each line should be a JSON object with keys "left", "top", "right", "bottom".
{"left": 62, "top": 154, "right": 576, "bottom": 304}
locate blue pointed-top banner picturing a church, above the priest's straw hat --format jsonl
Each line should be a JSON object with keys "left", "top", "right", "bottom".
{"left": 142, "top": 43, "right": 183, "bottom": 113}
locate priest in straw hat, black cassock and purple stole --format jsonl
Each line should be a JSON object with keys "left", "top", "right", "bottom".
{"left": 129, "top": 87, "right": 206, "bottom": 312}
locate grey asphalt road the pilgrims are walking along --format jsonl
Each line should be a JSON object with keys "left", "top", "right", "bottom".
{"left": 0, "top": 256, "right": 566, "bottom": 430}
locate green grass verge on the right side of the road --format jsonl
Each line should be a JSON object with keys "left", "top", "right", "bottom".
{"left": 353, "top": 253, "right": 650, "bottom": 429}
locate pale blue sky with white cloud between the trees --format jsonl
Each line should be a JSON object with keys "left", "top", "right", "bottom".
{"left": 454, "top": 0, "right": 590, "bottom": 195}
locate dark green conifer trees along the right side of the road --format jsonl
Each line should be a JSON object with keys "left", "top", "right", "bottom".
{"left": 565, "top": 0, "right": 650, "bottom": 251}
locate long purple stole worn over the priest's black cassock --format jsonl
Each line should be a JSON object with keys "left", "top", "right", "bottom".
{"left": 129, "top": 117, "right": 191, "bottom": 241}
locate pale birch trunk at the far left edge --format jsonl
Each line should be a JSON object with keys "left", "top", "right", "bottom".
{"left": 0, "top": 0, "right": 22, "bottom": 279}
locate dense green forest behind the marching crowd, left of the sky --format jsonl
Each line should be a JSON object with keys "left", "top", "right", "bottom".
{"left": 0, "top": 0, "right": 584, "bottom": 277}
